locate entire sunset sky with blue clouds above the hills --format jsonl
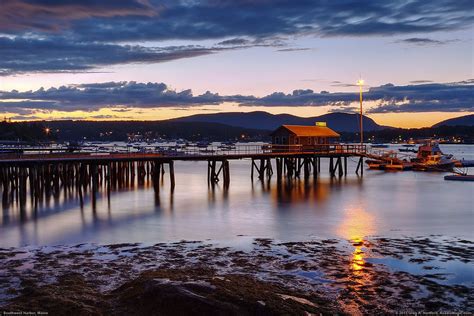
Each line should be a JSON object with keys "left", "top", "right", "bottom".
{"left": 0, "top": 0, "right": 474, "bottom": 127}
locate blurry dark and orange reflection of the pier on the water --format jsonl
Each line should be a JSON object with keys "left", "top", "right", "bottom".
{"left": 0, "top": 170, "right": 361, "bottom": 235}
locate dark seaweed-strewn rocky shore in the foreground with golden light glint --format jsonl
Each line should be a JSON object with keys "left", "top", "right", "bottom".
{"left": 0, "top": 236, "right": 474, "bottom": 315}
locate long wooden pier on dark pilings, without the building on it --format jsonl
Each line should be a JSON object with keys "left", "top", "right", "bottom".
{"left": 0, "top": 144, "right": 366, "bottom": 208}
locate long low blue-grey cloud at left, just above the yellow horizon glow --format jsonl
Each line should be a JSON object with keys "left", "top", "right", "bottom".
{"left": 0, "top": 82, "right": 222, "bottom": 112}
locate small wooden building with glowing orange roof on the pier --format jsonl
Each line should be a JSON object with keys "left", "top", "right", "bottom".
{"left": 270, "top": 122, "right": 340, "bottom": 146}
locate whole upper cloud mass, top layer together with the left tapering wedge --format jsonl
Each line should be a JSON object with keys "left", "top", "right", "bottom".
{"left": 0, "top": 0, "right": 474, "bottom": 75}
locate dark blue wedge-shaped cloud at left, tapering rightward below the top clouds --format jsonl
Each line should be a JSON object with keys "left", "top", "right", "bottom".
{"left": 0, "top": 37, "right": 222, "bottom": 75}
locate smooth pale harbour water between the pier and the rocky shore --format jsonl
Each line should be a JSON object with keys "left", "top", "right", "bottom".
{"left": 0, "top": 145, "right": 474, "bottom": 247}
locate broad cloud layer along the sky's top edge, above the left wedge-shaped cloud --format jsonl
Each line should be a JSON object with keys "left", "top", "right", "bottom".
{"left": 0, "top": 0, "right": 473, "bottom": 41}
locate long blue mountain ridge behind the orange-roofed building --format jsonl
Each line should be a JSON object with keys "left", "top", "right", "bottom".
{"left": 169, "top": 111, "right": 386, "bottom": 132}
